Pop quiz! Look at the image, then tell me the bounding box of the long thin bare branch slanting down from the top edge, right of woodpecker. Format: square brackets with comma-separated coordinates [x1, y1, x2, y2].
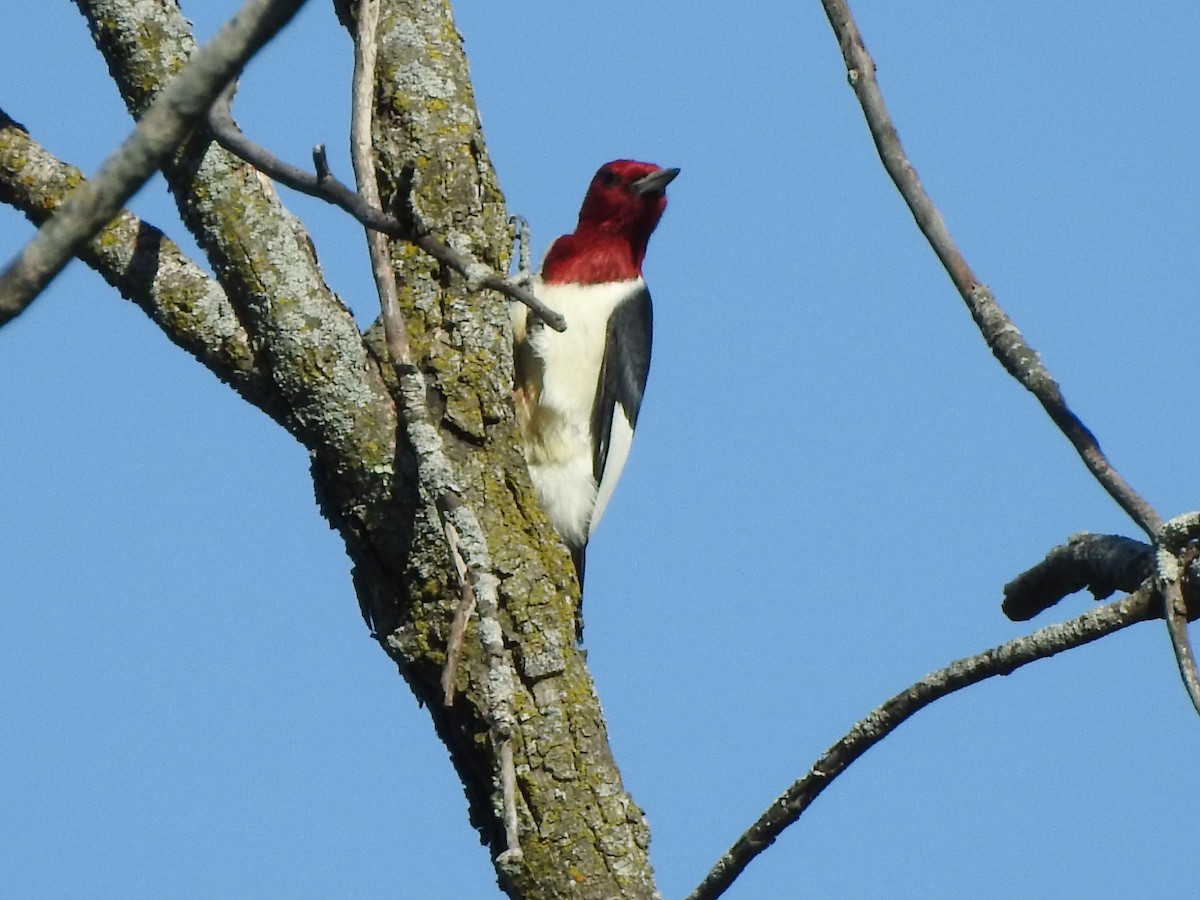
[821, 0, 1163, 539]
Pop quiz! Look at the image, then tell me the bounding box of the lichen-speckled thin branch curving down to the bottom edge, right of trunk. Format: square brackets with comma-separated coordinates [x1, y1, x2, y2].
[688, 582, 1160, 900]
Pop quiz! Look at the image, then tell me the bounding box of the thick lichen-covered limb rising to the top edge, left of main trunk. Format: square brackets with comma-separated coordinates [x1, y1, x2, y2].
[76, 0, 396, 509]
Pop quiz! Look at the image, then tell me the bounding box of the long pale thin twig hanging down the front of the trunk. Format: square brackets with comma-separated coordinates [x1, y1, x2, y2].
[345, 0, 522, 864]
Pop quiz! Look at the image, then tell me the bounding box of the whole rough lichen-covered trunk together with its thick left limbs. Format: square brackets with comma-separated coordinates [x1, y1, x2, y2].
[21, 0, 658, 900]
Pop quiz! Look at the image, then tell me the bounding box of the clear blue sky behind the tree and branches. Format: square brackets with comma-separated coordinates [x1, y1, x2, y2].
[0, 0, 1200, 900]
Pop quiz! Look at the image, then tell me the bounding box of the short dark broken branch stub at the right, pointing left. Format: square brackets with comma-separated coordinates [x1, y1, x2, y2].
[1001, 534, 1153, 622]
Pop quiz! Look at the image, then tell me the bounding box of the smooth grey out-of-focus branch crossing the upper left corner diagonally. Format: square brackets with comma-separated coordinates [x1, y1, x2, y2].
[0, 0, 305, 325]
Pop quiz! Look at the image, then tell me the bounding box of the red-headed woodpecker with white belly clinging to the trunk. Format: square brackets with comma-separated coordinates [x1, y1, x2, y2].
[512, 160, 679, 600]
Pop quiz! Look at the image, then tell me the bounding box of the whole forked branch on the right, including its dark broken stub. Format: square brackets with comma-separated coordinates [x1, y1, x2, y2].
[688, 0, 1200, 900]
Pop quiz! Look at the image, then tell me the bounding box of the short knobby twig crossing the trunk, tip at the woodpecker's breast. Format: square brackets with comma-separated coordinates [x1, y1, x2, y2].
[209, 91, 566, 331]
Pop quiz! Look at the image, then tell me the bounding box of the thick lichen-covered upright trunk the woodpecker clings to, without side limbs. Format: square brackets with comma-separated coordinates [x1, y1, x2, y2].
[355, 0, 658, 900]
